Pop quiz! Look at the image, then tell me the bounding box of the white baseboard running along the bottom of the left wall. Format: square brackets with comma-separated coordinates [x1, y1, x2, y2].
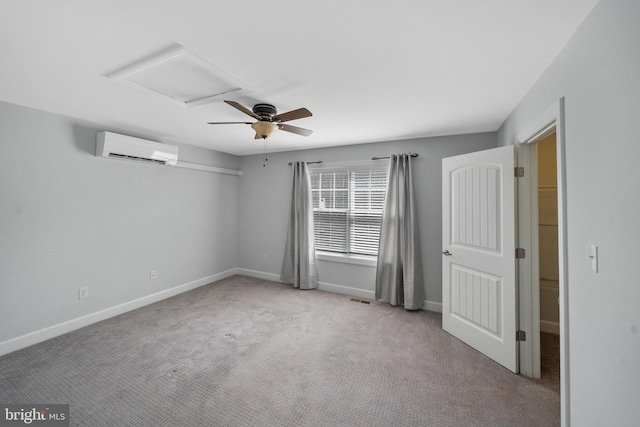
[0, 268, 238, 356]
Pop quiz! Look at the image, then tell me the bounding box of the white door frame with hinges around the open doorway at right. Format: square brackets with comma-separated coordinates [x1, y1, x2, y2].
[515, 97, 570, 426]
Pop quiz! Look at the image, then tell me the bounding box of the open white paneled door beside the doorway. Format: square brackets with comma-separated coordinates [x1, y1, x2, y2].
[442, 146, 518, 372]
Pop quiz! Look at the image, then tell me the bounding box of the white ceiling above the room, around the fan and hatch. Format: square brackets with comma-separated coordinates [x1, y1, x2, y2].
[0, 0, 597, 155]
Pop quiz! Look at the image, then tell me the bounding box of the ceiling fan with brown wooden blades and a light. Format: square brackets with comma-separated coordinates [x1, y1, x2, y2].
[208, 101, 313, 139]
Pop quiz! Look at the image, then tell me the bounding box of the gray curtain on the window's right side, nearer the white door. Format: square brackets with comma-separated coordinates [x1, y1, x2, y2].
[376, 154, 424, 310]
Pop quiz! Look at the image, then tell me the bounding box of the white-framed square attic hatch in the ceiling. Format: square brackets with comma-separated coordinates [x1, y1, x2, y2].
[106, 46, 250, 107]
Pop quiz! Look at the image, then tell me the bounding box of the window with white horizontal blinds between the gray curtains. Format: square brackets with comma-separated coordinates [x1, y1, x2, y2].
[311, 161, 389, 256]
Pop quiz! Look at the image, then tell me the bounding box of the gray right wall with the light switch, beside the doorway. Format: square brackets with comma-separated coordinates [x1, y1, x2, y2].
[498, 0, 640, 426]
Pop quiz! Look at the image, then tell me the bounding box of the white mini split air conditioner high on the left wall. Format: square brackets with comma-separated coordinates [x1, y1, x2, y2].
[96, 132, 178, 166]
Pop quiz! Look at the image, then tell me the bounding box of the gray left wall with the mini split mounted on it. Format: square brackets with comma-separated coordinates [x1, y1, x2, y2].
[0, 103, 239, 343]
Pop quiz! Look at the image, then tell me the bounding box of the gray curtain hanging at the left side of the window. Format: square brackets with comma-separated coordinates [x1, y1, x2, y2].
[280, 162, 318, 289]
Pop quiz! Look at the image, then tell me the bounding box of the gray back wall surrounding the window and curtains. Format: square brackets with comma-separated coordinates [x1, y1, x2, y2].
[238, 133, 496, 309]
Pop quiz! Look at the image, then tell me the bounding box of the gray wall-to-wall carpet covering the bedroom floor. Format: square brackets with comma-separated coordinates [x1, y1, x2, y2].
[0, 276, 560, 426]
